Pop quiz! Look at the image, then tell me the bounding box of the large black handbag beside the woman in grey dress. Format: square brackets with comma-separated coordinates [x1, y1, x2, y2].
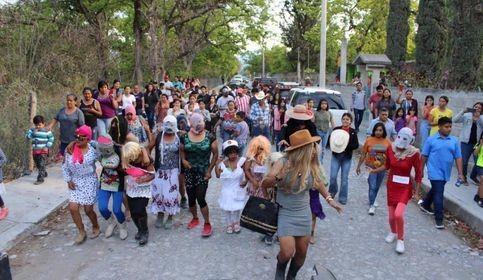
[240, 196, 281, 236]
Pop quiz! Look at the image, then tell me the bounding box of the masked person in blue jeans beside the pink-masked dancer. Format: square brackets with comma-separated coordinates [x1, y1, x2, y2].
[97, 136, 127, 240]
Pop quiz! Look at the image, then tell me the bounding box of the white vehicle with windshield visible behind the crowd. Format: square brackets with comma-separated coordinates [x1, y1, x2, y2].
[288, 87, 348, 126]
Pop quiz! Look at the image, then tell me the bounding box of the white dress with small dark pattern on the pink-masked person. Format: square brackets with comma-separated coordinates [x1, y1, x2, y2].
[62, 145, 99, 205]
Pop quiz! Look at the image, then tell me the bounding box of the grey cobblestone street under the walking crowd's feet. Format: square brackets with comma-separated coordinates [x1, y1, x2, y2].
[10, 152, 483, 280]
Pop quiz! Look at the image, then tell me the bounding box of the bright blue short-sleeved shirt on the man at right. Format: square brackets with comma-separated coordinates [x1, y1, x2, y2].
[421, 133, 461, 182]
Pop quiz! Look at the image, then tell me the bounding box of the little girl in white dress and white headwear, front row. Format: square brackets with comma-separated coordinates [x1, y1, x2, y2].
[215, 140, 248, 234]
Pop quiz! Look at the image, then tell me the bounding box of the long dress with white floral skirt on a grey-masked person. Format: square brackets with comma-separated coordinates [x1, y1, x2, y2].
[151, 137, 180, 215]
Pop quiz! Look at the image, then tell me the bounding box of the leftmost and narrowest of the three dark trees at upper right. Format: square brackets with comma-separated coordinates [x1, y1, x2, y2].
[386, 0, 411, 70]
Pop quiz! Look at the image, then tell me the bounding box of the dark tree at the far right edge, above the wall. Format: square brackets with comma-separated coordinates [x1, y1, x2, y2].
[449, 0, 483, 89]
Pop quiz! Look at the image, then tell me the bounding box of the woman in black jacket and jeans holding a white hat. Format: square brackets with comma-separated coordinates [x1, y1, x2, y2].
[329, 113, 359, 205]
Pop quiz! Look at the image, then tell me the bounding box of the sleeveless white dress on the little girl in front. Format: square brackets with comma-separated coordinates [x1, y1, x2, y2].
[218, 157, 248, 211]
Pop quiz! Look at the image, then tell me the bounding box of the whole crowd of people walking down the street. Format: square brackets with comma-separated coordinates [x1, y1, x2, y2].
[0, 76, 483, 279]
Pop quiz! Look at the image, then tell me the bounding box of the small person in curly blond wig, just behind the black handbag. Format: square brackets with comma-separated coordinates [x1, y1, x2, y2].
[243, 135, 273, 245]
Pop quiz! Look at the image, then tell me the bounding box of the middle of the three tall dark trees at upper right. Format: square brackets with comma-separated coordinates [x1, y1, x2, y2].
[415, 0, 448, 86]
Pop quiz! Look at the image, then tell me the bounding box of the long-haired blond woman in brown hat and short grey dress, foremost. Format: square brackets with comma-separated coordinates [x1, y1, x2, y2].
[261, 129, 342, 279]
